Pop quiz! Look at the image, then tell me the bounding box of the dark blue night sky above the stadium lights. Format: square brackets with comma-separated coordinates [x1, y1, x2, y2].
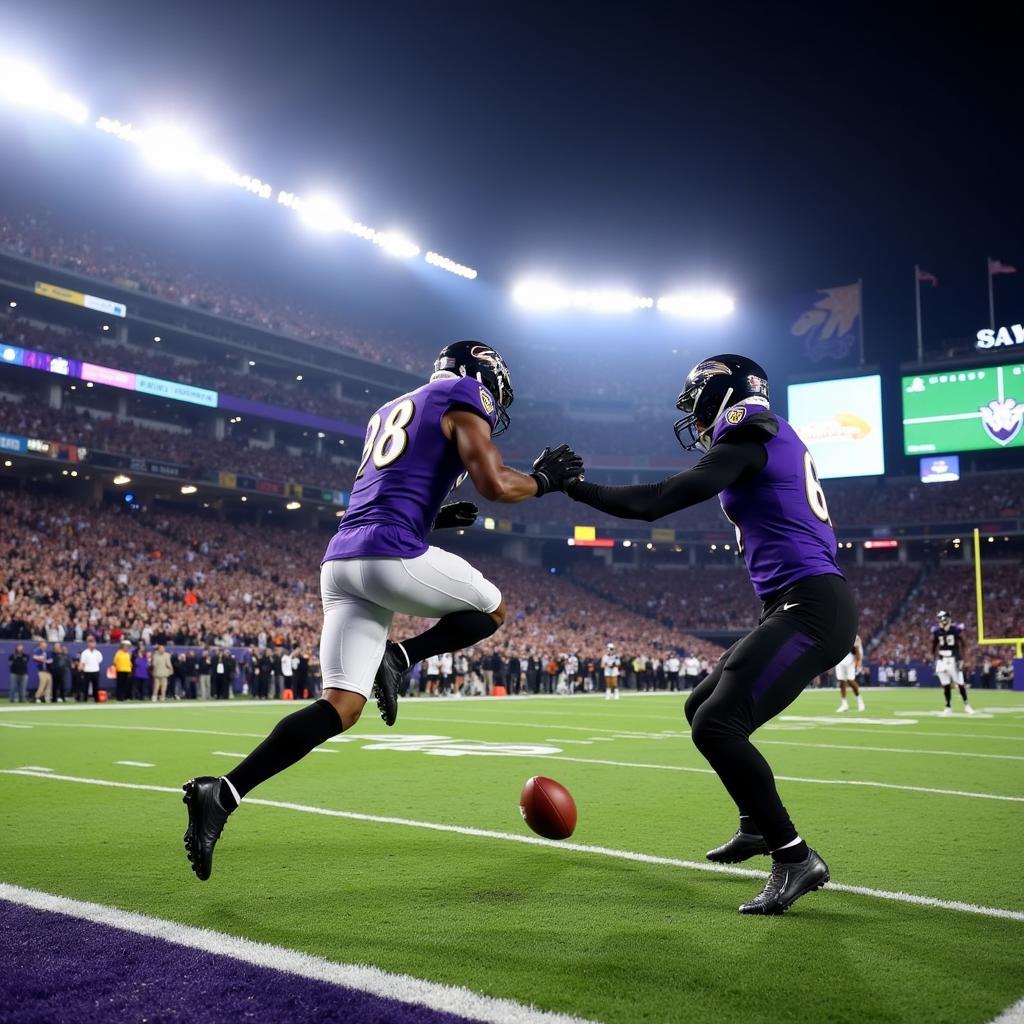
[3, 0, 1024, 362]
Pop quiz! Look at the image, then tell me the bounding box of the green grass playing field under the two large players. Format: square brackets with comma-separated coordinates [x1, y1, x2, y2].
[0, 690, 1024, 1024]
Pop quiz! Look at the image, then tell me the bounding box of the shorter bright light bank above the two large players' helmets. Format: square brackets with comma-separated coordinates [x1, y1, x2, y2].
[512, 278, 736, 321]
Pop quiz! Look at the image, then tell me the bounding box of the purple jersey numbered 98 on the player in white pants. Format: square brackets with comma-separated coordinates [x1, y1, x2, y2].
[324, 377, 496, 561]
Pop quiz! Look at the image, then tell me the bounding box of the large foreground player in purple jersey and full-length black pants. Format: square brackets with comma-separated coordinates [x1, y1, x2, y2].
[567, 355, 857, 913]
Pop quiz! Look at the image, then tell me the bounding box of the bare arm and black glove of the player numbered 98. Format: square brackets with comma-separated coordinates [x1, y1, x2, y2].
[442, 410, 583, 504]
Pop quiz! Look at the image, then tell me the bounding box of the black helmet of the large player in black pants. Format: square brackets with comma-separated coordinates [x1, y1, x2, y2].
[675, 355, 768, 452]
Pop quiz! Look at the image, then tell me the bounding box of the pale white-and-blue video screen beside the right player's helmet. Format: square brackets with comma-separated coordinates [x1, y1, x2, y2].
[786, 374, 886, 480]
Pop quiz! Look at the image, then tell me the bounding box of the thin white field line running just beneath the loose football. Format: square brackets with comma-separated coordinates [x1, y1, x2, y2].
[0, 759, 1024, 922]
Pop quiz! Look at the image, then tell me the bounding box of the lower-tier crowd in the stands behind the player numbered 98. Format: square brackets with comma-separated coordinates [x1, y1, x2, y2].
[0, 493, 720, 686]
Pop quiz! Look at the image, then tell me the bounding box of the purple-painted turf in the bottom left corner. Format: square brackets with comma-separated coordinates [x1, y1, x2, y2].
[0, 900, 465, 1024]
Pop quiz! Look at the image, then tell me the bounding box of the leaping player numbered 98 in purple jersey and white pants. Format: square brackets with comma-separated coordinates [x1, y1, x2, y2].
[183, 341, 583, 881]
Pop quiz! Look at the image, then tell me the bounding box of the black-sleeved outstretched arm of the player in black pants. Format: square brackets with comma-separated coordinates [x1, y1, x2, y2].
[566, 441, 768, 522]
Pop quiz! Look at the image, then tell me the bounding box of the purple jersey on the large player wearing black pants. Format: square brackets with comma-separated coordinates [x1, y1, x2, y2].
[712, 399, 843, 598]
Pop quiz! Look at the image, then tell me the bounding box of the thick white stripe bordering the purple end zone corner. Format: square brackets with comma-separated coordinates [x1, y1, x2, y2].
[0, 883, 587, 1024]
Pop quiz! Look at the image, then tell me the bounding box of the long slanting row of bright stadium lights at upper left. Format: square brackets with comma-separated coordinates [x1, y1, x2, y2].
[0, 56, 476, 281]
